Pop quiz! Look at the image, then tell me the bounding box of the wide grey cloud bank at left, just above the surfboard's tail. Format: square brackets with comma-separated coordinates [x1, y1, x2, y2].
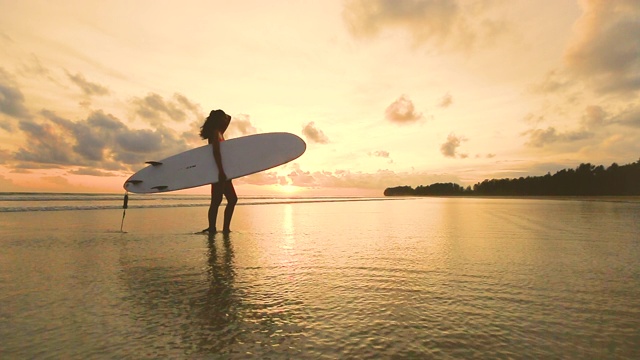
[10, 110, 189, 171]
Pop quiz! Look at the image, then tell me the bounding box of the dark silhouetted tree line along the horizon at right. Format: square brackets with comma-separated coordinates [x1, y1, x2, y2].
[384, 160, 640, 196]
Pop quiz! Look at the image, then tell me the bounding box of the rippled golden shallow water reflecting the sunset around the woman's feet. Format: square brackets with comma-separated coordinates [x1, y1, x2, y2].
[0, 198, 640, 358]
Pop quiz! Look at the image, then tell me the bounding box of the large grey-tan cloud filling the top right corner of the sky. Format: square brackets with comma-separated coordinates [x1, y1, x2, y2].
[564, 0, 640, 93]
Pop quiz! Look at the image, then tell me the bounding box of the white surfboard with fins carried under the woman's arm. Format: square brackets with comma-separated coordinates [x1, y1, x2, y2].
[123, 132, 307, 194]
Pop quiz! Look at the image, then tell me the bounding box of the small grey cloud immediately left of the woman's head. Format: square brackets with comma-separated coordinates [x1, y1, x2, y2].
[132, 93, 204, 126]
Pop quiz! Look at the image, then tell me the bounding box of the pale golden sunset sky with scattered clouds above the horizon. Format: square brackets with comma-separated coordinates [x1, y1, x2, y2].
[0, 0, 640, 196]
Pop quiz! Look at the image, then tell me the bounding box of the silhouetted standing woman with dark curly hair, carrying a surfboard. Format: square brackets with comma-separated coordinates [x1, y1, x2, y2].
[200, 110, 238, 234]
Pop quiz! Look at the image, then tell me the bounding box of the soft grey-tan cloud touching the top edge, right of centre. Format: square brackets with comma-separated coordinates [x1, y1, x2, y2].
[343, 0, 506, 50]
